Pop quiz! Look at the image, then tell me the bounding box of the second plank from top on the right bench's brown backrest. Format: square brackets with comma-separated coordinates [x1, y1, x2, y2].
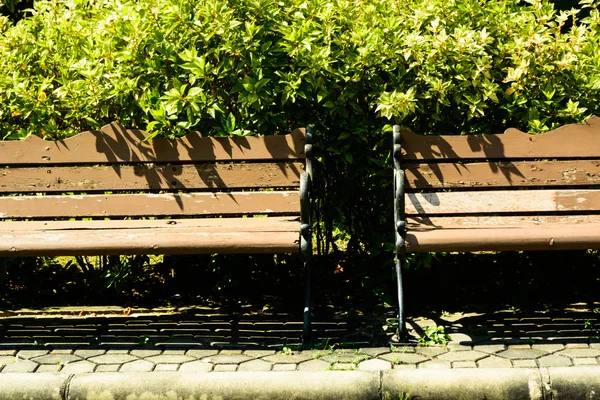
[406, 160, 600, 189]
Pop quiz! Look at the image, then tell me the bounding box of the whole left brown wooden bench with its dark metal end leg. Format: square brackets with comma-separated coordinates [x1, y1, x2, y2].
[0, 123, 312, 340]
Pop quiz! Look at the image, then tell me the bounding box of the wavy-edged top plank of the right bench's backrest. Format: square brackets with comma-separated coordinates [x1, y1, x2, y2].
[401, 116, 600, 160]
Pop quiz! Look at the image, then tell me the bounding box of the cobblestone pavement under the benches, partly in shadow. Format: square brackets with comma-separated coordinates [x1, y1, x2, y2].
[0, 306, 600, 374]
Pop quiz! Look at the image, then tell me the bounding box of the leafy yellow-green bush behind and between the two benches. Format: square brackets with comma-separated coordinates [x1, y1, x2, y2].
[0, 0, 600, 304]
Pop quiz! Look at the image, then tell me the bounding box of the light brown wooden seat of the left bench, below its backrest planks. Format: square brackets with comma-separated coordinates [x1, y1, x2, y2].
[0, 217, 300, 257]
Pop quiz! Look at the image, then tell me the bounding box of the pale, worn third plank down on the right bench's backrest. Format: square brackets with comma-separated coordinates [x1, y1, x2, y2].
[405, 190, 600, 215]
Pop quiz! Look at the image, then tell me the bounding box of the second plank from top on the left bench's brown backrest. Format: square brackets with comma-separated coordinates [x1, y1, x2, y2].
[0, 163, 304, 193]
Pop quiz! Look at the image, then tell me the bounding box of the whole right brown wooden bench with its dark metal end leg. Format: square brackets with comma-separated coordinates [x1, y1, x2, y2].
[393, 117, 600, 339]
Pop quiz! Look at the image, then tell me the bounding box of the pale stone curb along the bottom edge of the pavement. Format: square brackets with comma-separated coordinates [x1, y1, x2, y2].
[0, 367, 600, 400]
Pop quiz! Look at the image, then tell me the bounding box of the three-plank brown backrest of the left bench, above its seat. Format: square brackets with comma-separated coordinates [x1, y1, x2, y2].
[0, 123, 306, 220]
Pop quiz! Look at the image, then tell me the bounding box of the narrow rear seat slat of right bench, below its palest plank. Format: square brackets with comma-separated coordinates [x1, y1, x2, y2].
[406, 214, 600, 230]
